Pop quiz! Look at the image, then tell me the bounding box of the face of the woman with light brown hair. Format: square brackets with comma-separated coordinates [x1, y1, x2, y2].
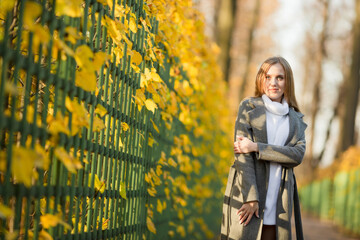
[263, 63, 285, 102]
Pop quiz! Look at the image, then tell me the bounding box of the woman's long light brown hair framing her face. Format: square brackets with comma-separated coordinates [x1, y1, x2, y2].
[255, 57, 300, 112]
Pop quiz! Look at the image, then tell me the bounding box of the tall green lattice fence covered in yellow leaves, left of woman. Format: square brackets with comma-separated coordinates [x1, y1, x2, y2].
[0, 0, 231, 239]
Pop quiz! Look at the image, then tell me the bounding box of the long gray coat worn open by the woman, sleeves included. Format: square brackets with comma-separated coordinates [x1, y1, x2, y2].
[221, 98, 307, 240]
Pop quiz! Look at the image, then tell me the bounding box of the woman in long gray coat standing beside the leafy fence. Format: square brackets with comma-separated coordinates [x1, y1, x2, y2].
[221, 57, 307, 240]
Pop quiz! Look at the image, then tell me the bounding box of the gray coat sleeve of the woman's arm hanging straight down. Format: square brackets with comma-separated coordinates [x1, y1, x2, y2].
[234, 100, 259, 202]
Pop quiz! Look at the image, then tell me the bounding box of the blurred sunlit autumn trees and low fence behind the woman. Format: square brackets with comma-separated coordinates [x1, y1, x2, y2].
[194, 0, 360, 239]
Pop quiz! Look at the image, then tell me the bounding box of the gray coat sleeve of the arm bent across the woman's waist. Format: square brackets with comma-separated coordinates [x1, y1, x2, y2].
[258, 128, 306, 168]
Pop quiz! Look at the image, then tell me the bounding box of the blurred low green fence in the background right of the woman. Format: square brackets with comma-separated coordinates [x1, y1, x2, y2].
[300, 169, 360, 235]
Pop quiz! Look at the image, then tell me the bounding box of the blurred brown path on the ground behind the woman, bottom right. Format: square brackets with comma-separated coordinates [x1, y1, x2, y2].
[292, 214, 360, 240]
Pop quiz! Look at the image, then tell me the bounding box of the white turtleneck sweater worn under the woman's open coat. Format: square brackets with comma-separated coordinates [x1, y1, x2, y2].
[262, 94, 289, 225]
